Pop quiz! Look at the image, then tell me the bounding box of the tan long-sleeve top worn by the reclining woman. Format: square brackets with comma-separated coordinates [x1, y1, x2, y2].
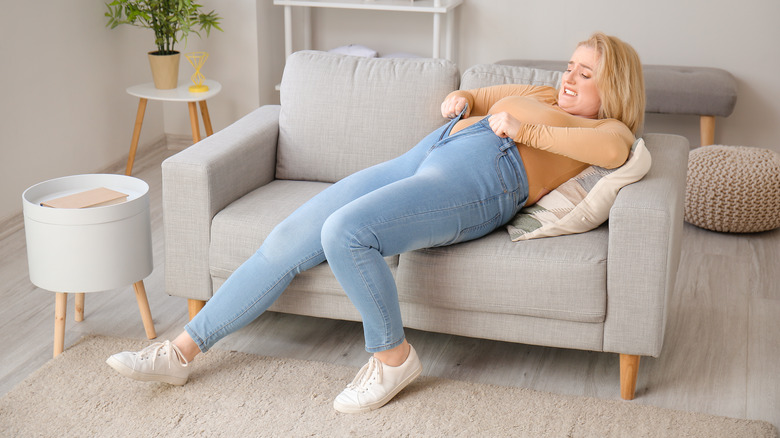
[448, 85, 635, 206]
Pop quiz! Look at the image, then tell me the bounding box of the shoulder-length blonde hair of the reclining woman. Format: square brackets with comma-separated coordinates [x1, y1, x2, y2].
[577, 32, 646, 135]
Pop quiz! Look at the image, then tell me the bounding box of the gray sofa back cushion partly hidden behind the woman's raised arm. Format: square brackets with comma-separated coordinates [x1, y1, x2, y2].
[460, 64, 563, 90]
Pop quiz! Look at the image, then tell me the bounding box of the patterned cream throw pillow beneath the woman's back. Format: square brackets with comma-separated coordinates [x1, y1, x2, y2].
[507, 138, 652, 241]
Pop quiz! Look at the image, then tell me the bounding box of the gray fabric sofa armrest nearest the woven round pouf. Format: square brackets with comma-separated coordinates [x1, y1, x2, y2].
[603, 134, 689, 357]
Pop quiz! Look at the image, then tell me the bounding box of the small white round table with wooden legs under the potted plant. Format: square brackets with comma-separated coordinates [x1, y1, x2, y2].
[125, 79, 222, 175]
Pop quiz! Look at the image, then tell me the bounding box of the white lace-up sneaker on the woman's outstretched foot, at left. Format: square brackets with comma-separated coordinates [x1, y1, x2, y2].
[106, 341, 190, 385]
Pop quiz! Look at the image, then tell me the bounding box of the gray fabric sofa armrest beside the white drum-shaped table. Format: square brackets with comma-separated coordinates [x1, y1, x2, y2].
[162, 105, 280, 301]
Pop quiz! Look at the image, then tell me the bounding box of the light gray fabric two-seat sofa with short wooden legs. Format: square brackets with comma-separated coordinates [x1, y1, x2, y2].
[162, 51, 688, 399]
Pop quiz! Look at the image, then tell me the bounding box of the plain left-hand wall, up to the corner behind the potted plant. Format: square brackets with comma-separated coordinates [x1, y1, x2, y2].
[0, 0, 163, 219]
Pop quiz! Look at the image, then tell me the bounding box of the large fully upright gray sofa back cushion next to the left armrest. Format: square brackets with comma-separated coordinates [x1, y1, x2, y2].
[276, 51, 459, 182]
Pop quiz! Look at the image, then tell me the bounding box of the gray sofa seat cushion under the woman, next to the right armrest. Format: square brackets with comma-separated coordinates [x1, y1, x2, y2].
[396, 225, 609, 323]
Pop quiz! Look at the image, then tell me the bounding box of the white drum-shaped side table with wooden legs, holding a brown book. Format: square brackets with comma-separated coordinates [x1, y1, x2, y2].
[22, 174, 157, 356]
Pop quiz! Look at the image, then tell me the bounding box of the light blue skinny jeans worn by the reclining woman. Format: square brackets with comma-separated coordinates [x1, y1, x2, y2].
[185, 112, 528, 353]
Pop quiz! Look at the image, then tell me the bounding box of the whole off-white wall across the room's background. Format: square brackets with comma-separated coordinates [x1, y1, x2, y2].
[0, 0, 780, 222]
